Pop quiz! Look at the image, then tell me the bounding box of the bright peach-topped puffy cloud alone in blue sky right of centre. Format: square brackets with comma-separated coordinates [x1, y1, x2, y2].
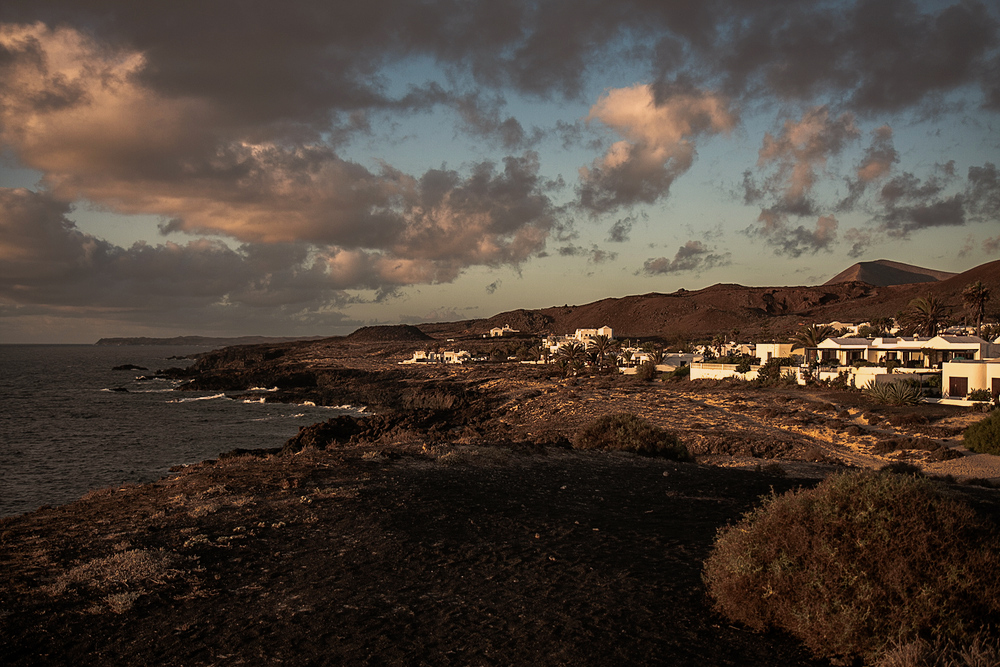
[578, 84, 737, 213]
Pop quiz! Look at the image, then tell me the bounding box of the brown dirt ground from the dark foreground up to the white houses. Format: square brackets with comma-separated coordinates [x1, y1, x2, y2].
[0, 344, 1000, 666]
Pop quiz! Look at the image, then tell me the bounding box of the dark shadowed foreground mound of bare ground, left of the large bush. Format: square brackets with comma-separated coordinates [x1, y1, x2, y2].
[0, 447, 824, 666]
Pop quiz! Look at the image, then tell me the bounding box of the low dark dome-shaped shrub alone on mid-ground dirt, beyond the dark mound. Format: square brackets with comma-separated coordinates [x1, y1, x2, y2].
[573, 412, 691, 461]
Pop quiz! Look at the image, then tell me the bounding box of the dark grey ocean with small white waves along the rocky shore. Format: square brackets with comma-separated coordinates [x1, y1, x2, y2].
[0, 345, 357, 516]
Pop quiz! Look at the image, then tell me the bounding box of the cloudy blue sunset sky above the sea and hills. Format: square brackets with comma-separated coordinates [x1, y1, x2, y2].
[0, 0, 1000, 343]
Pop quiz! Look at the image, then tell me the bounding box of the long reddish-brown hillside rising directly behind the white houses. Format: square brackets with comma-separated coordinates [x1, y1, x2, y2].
[420, 260, 1000, 339]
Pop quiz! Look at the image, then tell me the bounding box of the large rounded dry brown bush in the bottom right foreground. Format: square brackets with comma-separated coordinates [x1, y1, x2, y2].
[704, 473, 1000, 659]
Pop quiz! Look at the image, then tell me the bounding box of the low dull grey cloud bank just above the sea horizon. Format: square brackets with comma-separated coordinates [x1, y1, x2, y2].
[0, 188, 360, 318]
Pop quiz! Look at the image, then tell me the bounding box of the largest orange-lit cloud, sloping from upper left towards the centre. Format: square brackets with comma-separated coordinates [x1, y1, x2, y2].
[0, 24, 555, 286]
